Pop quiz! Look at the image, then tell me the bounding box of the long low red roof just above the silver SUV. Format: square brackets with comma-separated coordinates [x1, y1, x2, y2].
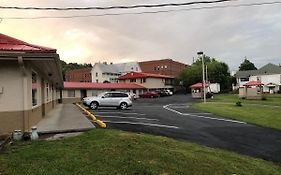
[64, 82, 146, 89]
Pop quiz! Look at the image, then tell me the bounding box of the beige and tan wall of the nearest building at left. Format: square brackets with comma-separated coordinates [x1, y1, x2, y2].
[0, 61, 57, 135]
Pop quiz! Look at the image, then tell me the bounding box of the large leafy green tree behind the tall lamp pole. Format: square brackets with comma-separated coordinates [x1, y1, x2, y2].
[177, 56, 232, 90]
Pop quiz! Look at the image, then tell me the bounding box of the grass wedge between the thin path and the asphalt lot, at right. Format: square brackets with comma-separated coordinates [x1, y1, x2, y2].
[192, 102, 281, 130]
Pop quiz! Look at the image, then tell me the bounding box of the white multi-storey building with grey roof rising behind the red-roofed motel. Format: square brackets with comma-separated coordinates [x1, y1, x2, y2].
[91, 62, 141, 83]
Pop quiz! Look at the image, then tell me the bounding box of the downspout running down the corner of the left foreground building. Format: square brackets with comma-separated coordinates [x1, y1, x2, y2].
[18, 56, 29, 132]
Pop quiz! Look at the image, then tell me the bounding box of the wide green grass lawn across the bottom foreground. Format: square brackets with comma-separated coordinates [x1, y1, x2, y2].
[0, 129, 281, 175]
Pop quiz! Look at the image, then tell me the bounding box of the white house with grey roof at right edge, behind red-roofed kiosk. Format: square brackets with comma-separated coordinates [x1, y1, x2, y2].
[236, 63, 281, 93]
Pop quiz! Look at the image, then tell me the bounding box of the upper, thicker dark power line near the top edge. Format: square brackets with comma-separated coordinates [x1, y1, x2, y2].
[0, 0, 235, 11]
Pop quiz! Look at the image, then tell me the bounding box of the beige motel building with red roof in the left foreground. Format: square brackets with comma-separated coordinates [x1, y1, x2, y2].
[0, 33, 63, 135]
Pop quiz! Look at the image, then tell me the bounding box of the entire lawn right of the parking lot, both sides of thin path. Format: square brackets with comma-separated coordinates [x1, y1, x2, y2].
[192, 94, 281, 130]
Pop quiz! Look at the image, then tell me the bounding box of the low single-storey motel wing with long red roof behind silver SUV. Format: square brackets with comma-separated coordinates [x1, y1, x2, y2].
[62, 82, 146, 103]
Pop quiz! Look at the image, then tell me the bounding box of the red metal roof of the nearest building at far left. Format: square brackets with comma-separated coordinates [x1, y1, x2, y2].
[0, 33, 56, 53]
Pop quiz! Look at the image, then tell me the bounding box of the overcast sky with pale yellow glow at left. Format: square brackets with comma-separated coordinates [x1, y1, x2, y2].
[0, 0, 281, 70]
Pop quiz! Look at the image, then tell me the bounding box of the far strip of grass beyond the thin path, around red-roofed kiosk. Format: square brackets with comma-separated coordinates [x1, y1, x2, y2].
[208, 94, 281, 106]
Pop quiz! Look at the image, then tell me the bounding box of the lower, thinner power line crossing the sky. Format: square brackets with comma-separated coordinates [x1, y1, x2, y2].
[1, 1, 281, 20]
